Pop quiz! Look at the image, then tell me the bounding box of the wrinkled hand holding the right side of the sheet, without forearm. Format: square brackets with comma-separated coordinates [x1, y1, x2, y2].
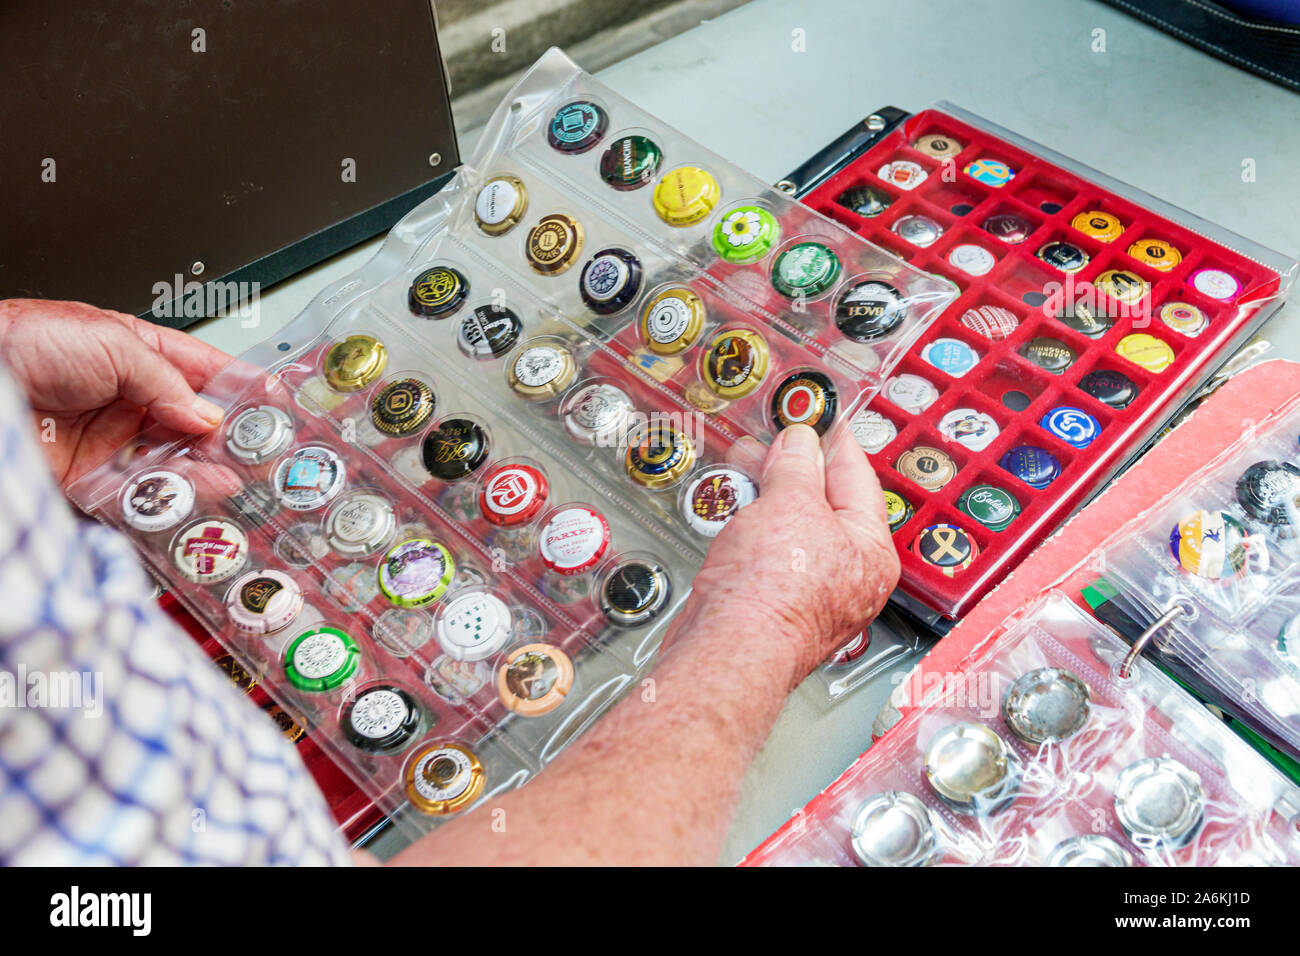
[694, 425, 898, 680]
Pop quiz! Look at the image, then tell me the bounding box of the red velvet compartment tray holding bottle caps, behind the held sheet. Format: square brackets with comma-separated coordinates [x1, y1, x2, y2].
[803, 111, 1281, 618]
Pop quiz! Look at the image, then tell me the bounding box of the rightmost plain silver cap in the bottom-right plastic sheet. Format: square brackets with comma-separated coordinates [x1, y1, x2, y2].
[1115, 757, 1205, 848]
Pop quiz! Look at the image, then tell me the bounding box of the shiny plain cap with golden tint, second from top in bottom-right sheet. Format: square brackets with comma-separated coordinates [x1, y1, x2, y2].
[926, 721, 1019, 816]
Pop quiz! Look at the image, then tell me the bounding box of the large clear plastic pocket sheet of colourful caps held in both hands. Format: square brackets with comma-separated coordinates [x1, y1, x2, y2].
[65, 51, 956, 832]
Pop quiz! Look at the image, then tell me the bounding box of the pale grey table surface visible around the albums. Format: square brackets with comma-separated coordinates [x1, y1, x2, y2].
[195, 0, 1300, 861]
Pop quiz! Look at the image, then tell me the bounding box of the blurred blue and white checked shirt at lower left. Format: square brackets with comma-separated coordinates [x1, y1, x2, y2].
[0, 365, 350, 865]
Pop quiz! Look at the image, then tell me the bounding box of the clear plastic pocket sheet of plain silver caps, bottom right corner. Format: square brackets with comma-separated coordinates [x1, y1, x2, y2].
[745, 592, 1300, 866]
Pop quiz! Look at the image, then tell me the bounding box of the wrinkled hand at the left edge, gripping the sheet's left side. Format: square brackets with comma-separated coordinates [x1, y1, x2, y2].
[0, 299, 230, 486]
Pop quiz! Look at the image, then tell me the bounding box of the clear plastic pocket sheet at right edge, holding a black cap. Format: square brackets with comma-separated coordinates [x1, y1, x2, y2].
[1096, 390, 1300, 758]
